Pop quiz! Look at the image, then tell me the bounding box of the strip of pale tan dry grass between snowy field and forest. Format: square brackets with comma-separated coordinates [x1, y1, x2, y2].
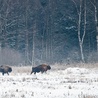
[4, 63, 98, 75]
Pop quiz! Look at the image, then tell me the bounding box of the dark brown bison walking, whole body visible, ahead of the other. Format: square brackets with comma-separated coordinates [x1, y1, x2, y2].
[31, 64, 51, 74]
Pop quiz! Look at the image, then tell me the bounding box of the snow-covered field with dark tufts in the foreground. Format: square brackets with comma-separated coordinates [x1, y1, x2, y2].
[0, 67, 98, 98]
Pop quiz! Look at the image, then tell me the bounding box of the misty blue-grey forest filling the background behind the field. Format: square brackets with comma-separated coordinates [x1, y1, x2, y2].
[0, 0, 98, 65]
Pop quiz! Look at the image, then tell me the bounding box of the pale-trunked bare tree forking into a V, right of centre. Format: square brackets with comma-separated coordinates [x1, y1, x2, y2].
[72, 0, 86, 62]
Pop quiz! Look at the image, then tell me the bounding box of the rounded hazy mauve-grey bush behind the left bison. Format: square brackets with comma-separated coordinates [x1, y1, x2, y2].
[0, 48, 24, 65]
